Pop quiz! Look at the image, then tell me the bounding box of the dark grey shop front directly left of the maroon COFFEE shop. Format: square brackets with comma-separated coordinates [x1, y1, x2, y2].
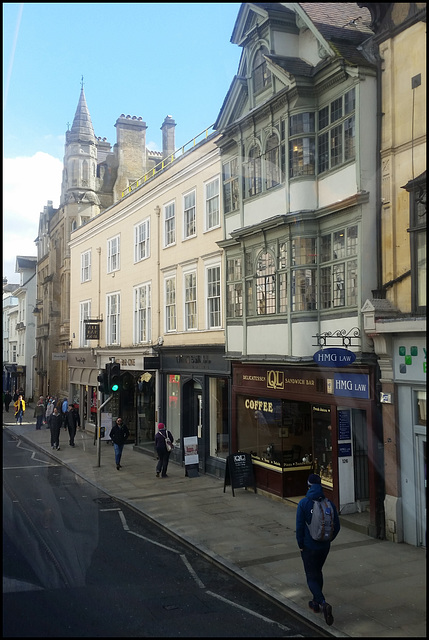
[161, 346, 231, 478]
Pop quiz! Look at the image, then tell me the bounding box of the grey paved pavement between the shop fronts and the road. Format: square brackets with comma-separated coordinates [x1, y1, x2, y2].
[3, 407, 427, 638]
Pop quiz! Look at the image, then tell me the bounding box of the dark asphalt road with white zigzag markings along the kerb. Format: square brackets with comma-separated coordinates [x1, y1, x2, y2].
[3, 432, 321, 637]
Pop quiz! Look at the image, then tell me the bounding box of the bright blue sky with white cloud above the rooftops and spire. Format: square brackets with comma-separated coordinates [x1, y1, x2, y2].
[2, 2, 242, 283]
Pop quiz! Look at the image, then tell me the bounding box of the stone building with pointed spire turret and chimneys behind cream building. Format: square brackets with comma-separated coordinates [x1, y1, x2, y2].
[35, 86, 175, 396]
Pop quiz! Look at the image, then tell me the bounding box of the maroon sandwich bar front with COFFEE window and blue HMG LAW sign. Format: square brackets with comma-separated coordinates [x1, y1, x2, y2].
[232, 363, 382, 532]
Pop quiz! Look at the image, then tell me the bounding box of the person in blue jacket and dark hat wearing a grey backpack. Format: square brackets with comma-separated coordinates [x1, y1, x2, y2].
[296, 473, 340, 625]
